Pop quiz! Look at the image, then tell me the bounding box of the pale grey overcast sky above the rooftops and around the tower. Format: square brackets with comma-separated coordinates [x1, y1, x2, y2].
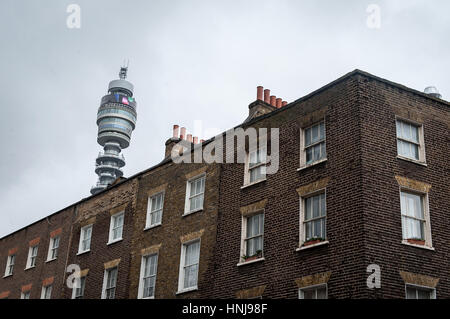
[0, 0, 450, 237]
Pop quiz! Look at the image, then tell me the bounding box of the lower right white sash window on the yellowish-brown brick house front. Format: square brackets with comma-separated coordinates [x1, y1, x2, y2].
[178, 240, 200, 292]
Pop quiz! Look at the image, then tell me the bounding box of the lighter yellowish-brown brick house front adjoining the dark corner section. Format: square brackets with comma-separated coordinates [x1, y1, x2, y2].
[129, 163, 220, 298]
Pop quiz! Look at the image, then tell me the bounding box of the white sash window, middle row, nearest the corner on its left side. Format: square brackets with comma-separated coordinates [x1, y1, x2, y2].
[300, 193, 327, 244]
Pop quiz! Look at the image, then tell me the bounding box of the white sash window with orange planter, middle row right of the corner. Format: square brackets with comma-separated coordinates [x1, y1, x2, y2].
[400, 191, 431, 246]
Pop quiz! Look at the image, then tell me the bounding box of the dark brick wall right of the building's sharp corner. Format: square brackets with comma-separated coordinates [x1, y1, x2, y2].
[359, 77, 450, 298]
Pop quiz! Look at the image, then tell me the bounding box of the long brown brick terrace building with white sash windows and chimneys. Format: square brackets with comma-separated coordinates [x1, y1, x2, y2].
[0, 70, 450, 298]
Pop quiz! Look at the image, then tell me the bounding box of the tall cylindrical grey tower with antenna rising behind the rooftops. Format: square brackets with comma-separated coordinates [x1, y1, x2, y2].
[91, 67, 137, 194]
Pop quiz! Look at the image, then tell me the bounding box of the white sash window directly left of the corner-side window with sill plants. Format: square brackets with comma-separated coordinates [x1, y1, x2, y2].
[241, 213, 264, 262]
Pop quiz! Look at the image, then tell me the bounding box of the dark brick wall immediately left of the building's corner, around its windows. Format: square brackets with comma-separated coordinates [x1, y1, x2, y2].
[212, 75, 365, 298]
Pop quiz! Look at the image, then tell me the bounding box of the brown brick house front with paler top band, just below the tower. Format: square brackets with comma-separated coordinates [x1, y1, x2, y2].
[61, 179, 138, 299]
